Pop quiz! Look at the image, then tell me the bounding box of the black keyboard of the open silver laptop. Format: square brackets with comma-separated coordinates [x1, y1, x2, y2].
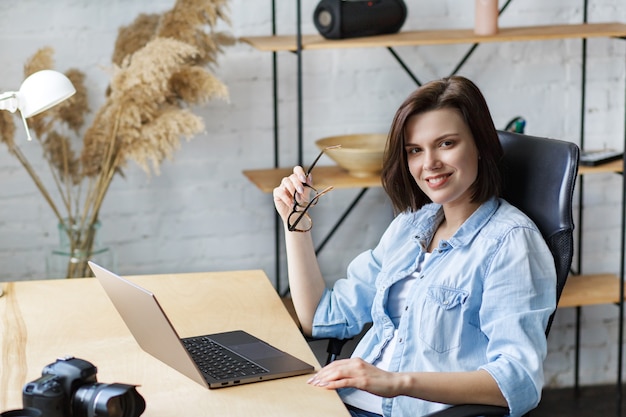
[182, 336, 268, 380]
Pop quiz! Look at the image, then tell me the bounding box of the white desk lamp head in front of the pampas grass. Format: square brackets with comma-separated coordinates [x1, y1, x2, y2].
[0, 70, 76, 140]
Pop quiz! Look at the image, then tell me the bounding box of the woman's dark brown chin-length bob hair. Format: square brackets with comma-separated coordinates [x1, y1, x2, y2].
[381, 76, 503, 213]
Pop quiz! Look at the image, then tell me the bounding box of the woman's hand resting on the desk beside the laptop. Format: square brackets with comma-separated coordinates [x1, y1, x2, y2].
[307, 358, 400, 397]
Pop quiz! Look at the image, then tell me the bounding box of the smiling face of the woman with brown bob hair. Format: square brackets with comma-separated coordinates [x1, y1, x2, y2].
[405, 108, 478, 207]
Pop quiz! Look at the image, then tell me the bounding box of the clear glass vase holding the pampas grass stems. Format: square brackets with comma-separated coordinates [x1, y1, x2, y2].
[46, 221, 116, 278]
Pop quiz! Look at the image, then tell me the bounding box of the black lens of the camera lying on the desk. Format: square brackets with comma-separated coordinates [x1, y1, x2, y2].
[72, 383, 146, 417]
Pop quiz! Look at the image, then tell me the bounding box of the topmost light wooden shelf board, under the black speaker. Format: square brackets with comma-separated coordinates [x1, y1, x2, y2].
[239, 22, 626, 52]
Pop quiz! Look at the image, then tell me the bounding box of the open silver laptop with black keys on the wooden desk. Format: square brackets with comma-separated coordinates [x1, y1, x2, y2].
[89, 262, 313, 388]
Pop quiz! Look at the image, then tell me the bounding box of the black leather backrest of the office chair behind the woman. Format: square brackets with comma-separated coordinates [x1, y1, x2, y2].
[498, 132, 579, 334]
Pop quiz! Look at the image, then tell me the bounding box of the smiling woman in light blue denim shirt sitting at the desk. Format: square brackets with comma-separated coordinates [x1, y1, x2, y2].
[274, 76, 556, 417]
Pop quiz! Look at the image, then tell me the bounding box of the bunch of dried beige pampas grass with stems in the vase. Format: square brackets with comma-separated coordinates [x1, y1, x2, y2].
[0, 0, 235, 277]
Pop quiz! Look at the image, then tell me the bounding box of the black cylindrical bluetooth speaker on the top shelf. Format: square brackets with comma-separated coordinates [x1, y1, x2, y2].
[313, 0, 406, 39]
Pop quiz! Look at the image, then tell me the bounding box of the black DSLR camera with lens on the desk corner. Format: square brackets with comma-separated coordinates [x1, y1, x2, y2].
[22, 357, 146, 417]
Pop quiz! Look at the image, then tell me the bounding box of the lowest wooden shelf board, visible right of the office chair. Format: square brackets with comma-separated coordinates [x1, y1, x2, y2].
[559, 274, 619, 308]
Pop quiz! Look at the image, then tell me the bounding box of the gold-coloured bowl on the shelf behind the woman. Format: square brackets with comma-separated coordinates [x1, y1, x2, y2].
[315, 133, 387, 178]
